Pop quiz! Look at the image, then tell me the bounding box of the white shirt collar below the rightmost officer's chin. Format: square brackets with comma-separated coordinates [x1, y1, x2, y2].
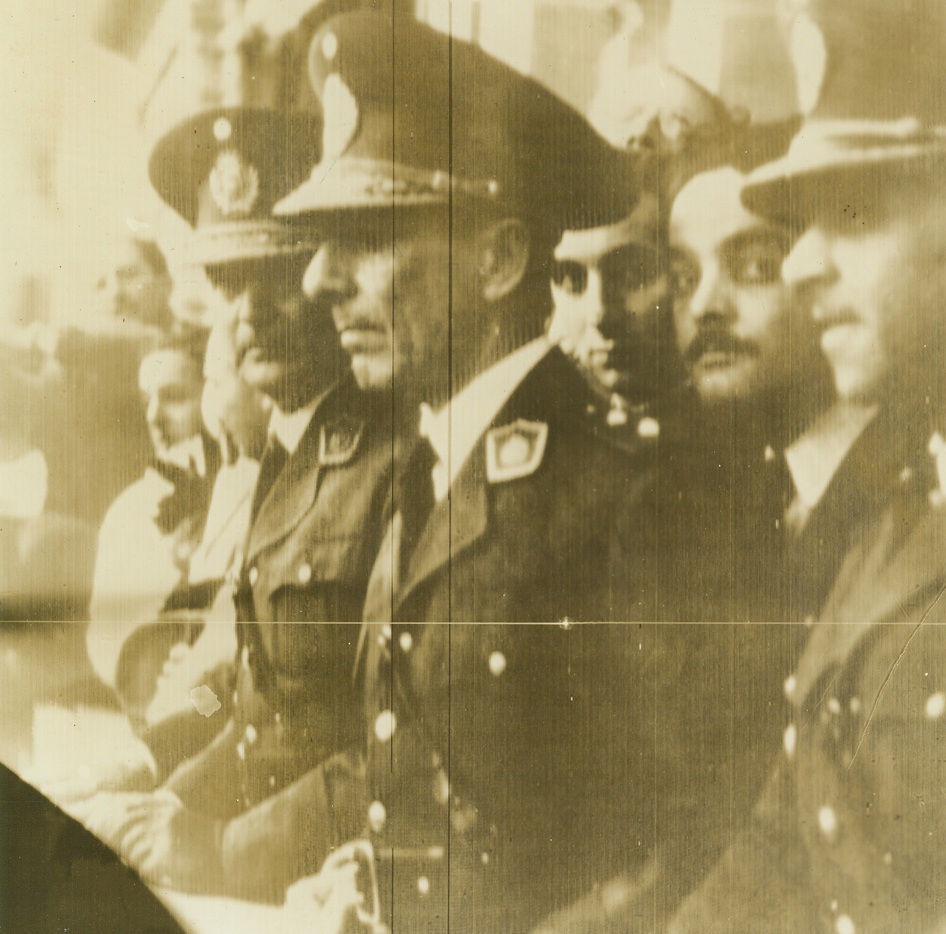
[785, 400, 879, 510]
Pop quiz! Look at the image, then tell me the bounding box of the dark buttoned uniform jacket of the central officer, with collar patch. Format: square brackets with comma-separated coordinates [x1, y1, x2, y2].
[354, 351, 716, 932]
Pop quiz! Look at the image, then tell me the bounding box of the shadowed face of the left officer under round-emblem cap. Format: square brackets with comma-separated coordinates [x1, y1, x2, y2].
[206, 253, 337, 412]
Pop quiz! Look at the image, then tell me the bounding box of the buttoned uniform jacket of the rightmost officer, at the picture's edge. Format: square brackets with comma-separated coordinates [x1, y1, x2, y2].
[671, 464, 946, 934]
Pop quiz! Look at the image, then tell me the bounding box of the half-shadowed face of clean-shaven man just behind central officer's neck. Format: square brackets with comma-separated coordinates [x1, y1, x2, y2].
[549, 193, 668, 395]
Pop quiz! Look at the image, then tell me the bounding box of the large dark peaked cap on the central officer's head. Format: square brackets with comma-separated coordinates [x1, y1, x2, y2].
[275, 12, 638, 229]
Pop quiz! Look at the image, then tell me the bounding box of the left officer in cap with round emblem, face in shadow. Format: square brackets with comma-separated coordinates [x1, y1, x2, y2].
[74, 108, 393, 901]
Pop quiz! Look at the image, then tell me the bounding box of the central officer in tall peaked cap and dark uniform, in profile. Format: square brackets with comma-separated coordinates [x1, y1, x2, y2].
[275, 14, 728, 931]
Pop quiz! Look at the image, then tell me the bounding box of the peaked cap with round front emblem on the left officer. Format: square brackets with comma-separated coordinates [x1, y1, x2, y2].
[148, 107, 322, 265]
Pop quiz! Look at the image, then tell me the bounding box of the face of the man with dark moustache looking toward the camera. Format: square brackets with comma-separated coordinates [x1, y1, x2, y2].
[670, 168, 816, 403]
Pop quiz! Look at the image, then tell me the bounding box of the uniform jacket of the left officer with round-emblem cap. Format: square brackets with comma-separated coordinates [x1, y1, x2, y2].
[170, 381, 402, 899]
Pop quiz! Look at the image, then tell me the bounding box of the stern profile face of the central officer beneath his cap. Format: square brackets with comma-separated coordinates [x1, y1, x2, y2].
[304, 207, 464, 399]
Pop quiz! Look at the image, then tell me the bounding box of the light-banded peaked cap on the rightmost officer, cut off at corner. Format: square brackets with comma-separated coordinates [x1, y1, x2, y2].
[743, 0, 946, 217]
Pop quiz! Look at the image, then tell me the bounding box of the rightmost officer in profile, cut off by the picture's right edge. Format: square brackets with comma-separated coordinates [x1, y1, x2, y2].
[671, 0, 946, 934]
